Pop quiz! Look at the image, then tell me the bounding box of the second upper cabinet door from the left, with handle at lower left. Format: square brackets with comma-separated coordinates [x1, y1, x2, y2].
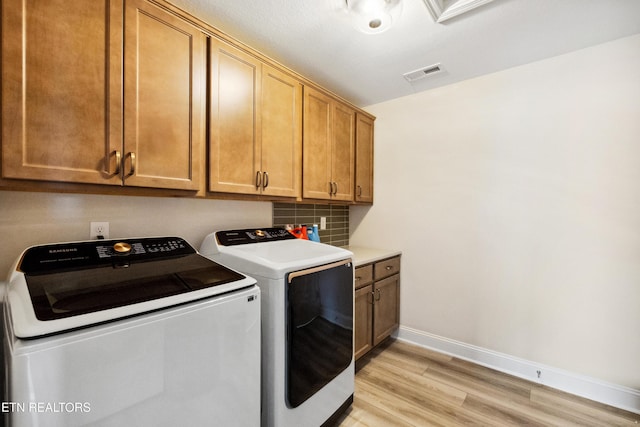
[123, 0, 206, 190]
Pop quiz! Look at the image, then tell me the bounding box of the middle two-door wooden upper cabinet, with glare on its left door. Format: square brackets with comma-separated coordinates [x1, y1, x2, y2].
[209, 39, 302, 197]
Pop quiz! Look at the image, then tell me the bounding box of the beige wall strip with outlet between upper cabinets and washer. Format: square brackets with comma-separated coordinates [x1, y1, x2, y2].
[0, 191, 272, 281]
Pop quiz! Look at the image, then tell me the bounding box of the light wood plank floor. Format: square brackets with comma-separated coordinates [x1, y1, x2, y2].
[337, 340, 640, 427]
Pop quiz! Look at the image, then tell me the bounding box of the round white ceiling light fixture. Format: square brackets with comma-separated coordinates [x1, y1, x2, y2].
[345, 0, 402, 34]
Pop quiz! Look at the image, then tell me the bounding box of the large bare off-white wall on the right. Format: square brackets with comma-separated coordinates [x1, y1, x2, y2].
[351, 35, 640, 390]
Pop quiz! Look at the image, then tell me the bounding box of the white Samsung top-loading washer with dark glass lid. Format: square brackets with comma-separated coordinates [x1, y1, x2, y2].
[3, 237, 260, 427]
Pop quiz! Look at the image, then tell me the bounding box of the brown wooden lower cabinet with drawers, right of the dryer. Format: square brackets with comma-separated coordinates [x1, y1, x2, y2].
[353, 256, 400, 360]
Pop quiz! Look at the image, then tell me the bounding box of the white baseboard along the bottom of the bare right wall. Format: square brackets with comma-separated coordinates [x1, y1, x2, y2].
[395, 326, 640, 414]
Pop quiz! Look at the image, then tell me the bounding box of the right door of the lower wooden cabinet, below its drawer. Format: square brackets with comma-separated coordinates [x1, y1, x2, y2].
[373, 274, 400, 346]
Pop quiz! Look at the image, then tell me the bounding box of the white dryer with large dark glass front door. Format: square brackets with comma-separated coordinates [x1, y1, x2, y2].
[200, 228, 354, 427]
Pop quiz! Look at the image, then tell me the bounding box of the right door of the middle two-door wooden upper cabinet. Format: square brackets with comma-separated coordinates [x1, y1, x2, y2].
[260, 65, 302, 197]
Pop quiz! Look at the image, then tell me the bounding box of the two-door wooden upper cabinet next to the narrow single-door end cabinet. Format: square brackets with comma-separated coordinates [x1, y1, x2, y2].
[302, 87, 355, 201]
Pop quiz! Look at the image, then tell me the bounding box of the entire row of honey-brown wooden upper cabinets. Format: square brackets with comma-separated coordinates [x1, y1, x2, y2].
[0, 0, 364, 203]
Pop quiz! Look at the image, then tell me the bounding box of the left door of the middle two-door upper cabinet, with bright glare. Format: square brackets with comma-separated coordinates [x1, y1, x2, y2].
[209, 39, 262, 194]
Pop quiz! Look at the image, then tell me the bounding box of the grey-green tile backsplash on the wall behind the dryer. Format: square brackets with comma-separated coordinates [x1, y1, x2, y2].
[273, 203, 349, 246]
